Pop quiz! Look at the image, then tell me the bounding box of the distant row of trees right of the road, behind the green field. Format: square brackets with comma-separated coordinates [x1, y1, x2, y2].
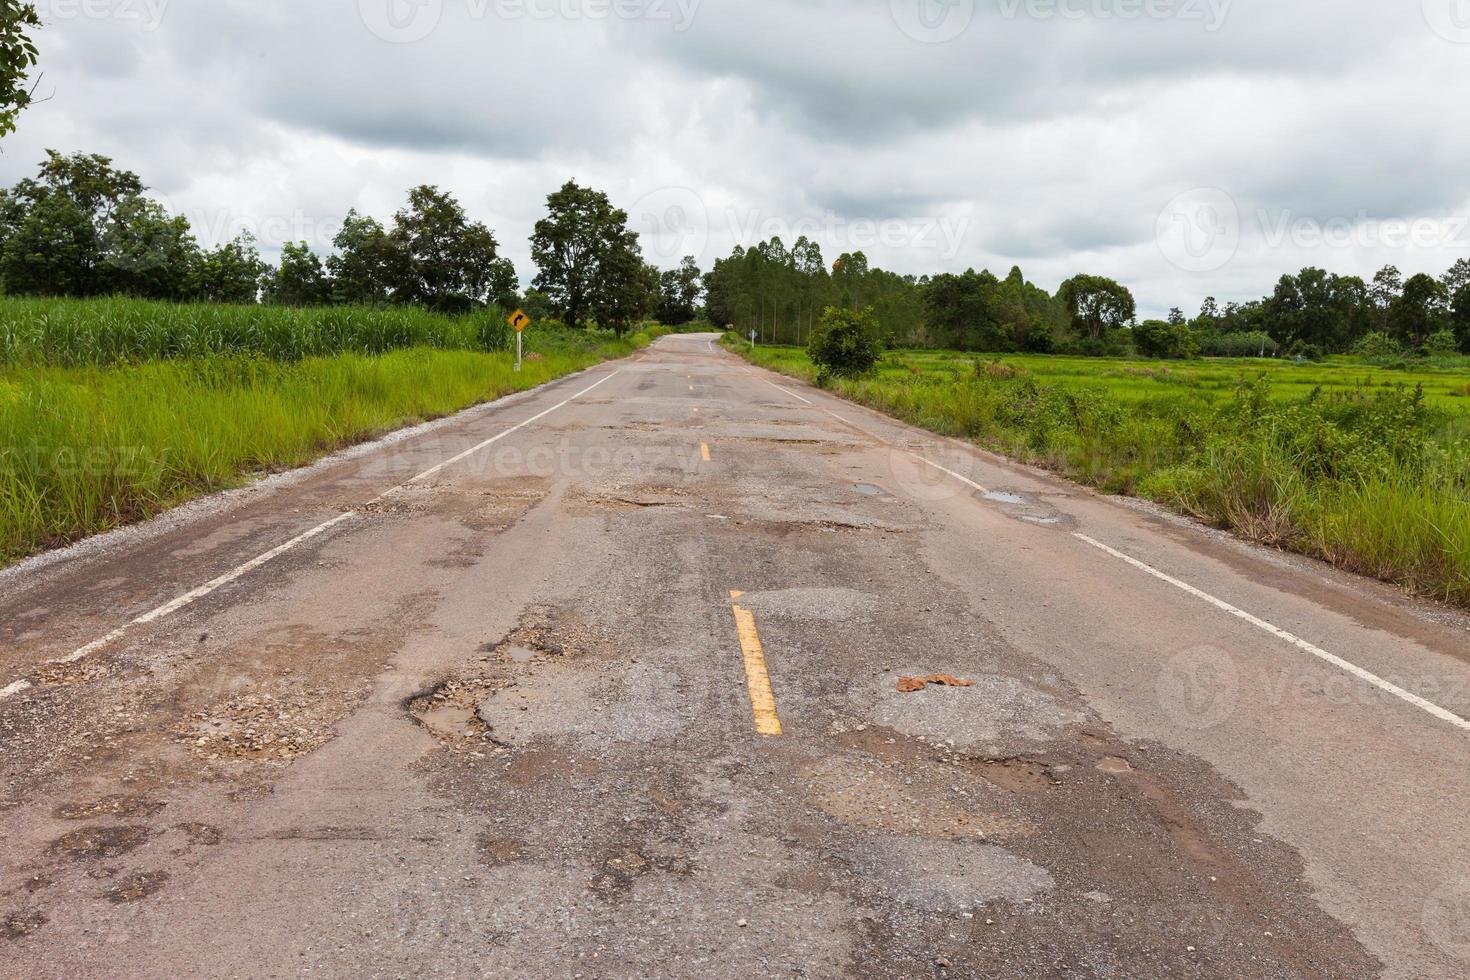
[704, 237, 1470, 357]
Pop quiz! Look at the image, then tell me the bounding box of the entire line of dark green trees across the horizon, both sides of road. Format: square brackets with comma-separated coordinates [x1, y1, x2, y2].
[0, 151, 1470, 357]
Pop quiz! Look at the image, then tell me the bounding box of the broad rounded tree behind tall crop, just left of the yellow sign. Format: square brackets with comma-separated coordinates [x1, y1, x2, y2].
[388, 184, 515, 310]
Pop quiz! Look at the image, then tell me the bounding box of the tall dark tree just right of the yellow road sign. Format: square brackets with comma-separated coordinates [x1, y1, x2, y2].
[531, 181, 642, 333]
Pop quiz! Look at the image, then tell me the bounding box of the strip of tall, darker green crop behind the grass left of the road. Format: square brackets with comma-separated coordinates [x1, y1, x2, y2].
[0, 297, 513, 366]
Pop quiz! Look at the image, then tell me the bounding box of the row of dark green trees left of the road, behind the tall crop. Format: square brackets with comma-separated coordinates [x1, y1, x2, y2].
[0, 151, 700, 334]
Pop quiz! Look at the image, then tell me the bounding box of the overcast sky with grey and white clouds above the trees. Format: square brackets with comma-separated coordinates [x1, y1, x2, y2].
[0, 0, 1470, 314]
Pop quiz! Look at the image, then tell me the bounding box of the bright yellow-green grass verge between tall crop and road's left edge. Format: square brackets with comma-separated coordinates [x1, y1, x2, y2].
[0, 331, 657, 564]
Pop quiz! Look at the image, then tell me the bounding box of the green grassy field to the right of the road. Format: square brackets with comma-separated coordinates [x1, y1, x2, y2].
[726, 338, 1470, 607]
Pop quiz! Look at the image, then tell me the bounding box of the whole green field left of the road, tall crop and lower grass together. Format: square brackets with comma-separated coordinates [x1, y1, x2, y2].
[0, 300, 661, 564]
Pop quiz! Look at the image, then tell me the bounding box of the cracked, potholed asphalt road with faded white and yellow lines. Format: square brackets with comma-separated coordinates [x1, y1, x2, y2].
[0, 335, 1470, 979]
